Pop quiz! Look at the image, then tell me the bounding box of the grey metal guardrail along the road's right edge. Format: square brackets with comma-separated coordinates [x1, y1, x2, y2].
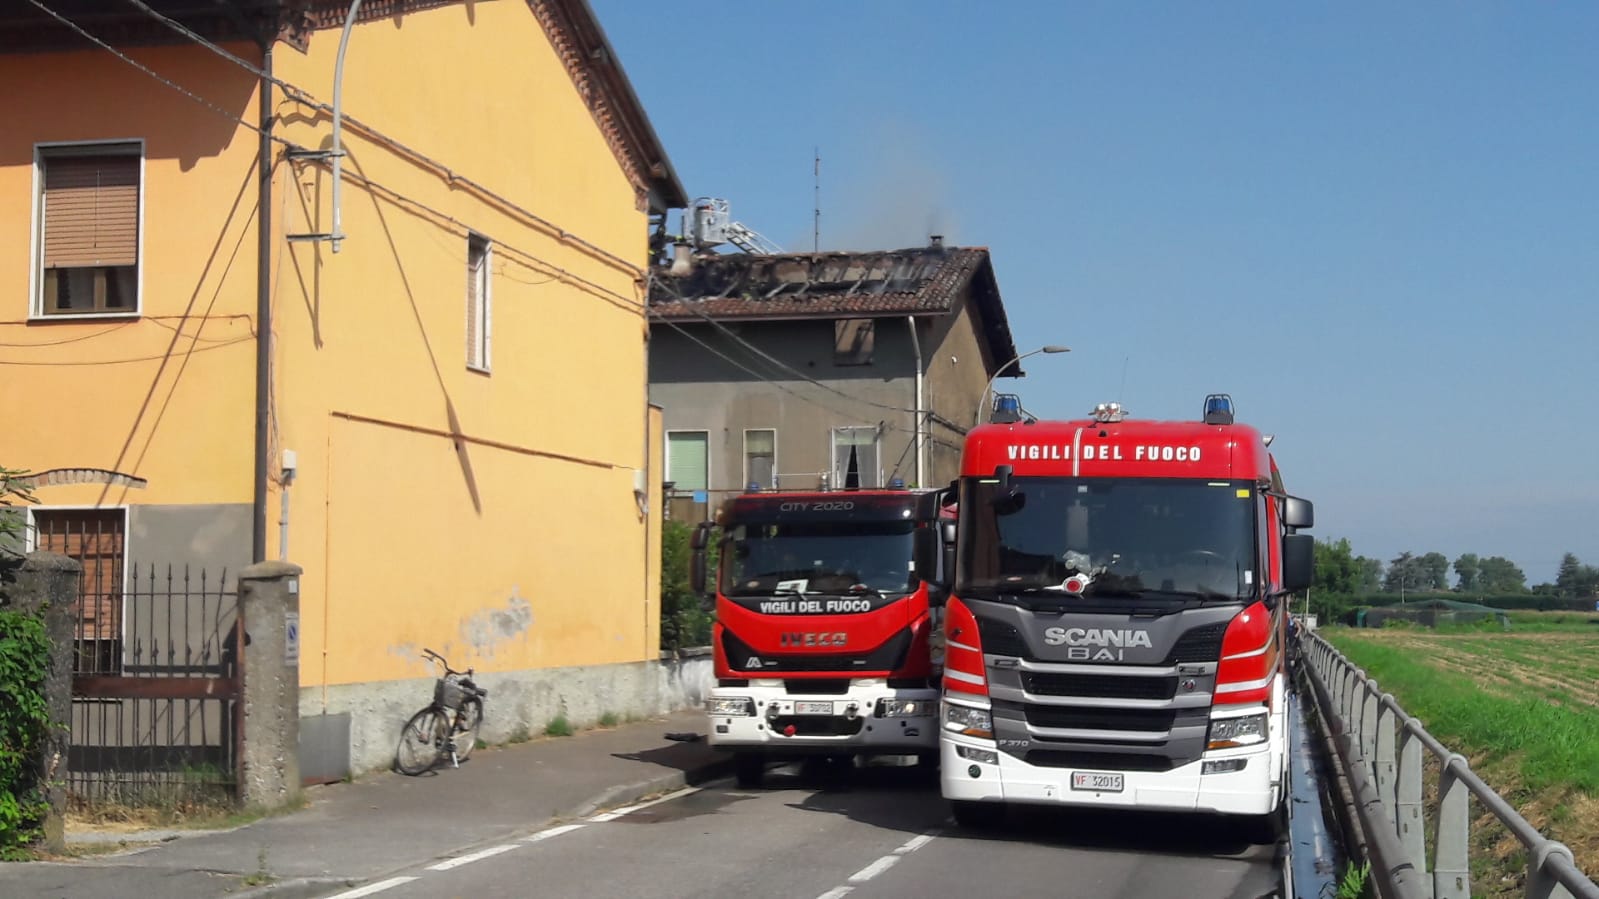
[1300, 633, 1599, 899]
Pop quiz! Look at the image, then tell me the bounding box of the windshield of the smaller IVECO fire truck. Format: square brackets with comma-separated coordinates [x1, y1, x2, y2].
[721, 521, 916, 597]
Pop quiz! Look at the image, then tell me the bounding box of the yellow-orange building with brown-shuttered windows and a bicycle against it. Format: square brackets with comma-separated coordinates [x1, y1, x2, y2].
[0, 0, 686, 769]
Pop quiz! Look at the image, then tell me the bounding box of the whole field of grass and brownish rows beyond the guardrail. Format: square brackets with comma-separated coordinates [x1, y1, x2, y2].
[1321, 613, 1599, 896]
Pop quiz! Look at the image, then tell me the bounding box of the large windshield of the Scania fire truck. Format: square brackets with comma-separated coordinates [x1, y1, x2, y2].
[955, 478, 1260, 600]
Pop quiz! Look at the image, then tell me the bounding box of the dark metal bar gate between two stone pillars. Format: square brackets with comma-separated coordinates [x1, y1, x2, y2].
[35, 510, 243, 809]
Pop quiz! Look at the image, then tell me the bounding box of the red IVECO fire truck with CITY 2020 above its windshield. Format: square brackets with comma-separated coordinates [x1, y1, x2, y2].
[692, 489, 955, 787]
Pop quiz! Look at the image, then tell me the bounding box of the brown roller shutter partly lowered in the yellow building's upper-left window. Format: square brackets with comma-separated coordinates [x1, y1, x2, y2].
[45, 155, 139, 269]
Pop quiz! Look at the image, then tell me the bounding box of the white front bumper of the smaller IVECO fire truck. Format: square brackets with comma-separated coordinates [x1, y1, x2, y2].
[705, 680, 939, 757]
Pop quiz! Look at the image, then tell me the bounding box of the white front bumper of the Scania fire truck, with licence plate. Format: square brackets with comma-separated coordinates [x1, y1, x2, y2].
[939, 733, 1284, 814]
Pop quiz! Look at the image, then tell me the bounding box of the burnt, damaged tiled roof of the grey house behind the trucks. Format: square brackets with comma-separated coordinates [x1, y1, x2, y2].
[649, 245, 1015, 374]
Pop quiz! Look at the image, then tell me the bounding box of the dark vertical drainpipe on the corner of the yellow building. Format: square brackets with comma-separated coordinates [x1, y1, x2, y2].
[251, 43, 277, 561]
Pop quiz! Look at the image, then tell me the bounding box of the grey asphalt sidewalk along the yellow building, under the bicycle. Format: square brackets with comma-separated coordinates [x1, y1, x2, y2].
[0, 710, 731, 899]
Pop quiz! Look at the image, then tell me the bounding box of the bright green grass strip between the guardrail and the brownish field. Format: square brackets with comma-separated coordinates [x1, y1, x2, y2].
[1329, 630, 1599, 793]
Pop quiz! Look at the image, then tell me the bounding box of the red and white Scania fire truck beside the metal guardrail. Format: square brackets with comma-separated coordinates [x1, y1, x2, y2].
[939, 394, 1313, 841]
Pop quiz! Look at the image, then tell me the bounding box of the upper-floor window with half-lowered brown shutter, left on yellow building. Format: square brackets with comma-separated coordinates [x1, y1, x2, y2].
[37, 144, 142, 315]
